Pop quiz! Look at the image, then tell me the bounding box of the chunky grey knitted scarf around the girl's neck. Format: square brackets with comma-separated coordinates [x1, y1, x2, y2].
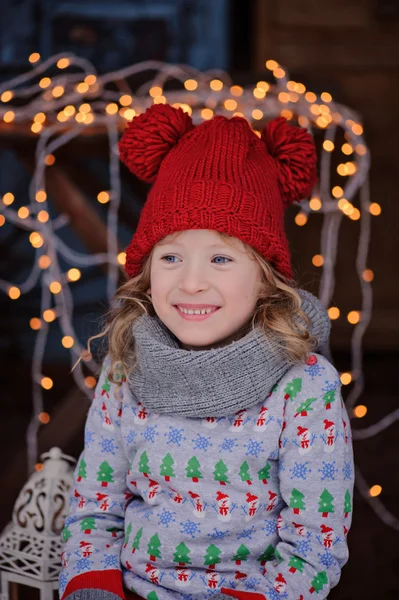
[128, 290, 330, 417]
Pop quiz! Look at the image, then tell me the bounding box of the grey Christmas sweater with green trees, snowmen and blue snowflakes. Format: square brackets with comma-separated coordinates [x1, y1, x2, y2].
[59, 354, 354, 600]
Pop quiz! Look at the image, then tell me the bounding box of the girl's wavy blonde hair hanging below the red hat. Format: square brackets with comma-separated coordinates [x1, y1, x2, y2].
[88, 232, 317, 385]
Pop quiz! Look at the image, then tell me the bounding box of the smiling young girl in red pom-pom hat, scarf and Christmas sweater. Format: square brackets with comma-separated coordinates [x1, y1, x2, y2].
[60, 105, 353, 600]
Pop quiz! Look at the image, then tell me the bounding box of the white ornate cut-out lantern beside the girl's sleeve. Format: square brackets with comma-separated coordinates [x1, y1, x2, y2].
[0, 448, 76, 600]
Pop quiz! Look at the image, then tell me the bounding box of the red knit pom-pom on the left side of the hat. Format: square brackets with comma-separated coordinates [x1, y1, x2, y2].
[119, 104, 194, 183]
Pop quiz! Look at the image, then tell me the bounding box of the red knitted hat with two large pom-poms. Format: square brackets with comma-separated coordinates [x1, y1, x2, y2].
[119, 104, 317, 278]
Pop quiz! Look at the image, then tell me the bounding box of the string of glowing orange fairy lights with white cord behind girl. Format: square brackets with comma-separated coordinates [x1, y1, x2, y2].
[0, 53, 399, 530]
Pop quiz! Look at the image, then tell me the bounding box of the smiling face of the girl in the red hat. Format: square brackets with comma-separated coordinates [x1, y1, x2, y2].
[150, 229, 262, 350]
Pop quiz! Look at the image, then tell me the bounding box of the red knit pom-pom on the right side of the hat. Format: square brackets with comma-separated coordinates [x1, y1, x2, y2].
[261, 117, 317, 205]
